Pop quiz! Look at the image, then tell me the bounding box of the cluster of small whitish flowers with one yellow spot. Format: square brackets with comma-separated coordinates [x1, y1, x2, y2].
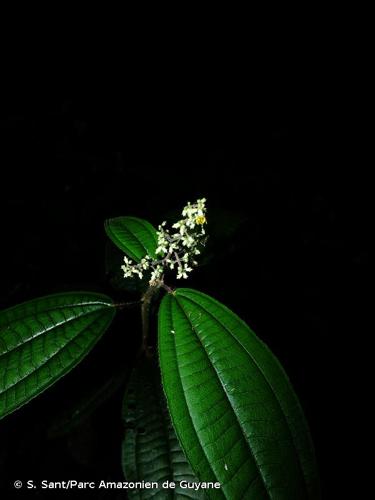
[121, 198, 207, 286]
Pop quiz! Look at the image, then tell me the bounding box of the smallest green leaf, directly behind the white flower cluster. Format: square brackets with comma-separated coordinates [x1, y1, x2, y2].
[104, 217, 157, 262]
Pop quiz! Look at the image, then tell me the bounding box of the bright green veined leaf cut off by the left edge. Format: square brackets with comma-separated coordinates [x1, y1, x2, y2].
[0, 292, 115, 418]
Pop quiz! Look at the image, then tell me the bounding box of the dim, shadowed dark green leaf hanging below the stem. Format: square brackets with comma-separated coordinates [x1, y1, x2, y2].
[122, 359, 203, 499]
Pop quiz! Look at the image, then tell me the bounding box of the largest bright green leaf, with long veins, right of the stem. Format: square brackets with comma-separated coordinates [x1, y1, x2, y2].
[159, 289, 320, 500]
